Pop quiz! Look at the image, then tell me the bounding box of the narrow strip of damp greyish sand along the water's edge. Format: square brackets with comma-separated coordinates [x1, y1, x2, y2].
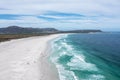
[38, 34, 63, 80]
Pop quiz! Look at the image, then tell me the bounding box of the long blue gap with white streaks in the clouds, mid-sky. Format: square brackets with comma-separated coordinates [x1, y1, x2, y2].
[38, 11, 85, 21]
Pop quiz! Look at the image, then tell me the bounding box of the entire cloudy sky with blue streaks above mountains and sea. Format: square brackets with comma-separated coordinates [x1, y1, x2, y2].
[0, 0, 120, 31]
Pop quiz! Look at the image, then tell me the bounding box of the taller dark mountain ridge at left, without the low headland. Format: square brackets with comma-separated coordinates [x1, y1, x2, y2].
[0, 26, 58, 34]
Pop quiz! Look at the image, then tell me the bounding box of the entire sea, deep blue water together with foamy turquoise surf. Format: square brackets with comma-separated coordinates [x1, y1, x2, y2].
[50, 33, 120, 80]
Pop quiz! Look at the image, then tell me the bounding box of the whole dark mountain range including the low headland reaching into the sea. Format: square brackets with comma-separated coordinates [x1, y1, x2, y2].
[0, 26, 102, 34]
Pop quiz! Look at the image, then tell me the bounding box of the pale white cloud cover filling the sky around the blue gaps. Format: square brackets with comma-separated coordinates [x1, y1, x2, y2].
[0, 0, 120, 28]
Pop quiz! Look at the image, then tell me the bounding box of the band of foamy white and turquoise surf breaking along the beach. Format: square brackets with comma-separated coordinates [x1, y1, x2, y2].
[51, 35, 104, 80]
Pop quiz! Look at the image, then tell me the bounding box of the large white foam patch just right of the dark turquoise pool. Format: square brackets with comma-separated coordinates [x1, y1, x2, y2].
[67, 55, 98, 71]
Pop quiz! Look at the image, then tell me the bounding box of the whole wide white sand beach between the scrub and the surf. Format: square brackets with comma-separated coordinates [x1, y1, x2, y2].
[0, 35, 60, 80]
